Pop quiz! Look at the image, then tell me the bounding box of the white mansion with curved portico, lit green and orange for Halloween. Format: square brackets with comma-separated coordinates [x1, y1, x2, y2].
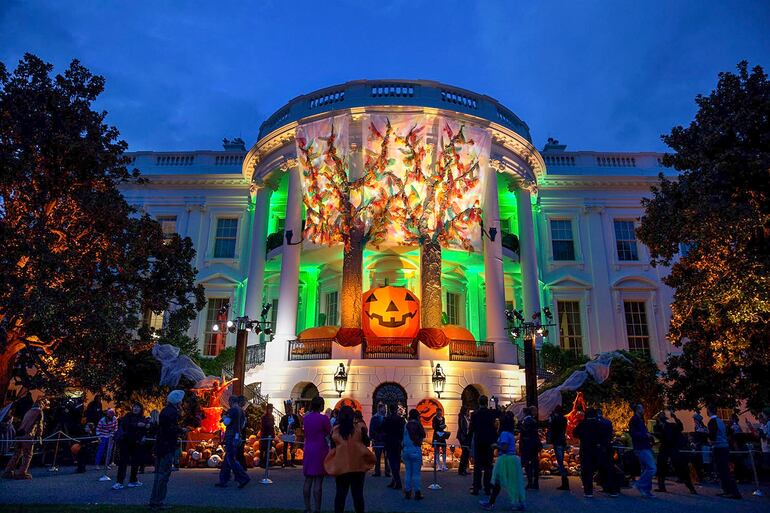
[124, 80, 672, 429]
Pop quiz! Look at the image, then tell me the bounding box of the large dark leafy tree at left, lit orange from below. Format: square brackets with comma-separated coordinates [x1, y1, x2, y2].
[0, 54, 204, 392]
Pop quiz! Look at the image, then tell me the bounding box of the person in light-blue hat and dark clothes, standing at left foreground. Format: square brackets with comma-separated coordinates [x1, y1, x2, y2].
[150, 390, 187, 509]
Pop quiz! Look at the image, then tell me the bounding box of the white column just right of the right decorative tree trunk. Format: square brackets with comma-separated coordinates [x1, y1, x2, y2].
[483, 166, 516, 364]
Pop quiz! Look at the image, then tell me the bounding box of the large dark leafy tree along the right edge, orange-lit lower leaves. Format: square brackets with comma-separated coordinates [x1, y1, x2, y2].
[638, 61, 770, 408]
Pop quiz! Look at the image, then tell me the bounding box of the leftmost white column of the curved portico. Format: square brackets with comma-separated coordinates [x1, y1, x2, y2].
[243, 186, 272, 344]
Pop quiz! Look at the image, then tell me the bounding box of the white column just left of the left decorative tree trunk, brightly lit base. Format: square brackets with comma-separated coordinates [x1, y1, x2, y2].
[265, 167, 302, 361]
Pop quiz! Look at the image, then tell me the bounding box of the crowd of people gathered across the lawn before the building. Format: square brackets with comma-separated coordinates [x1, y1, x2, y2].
[1, 390, 770, 513]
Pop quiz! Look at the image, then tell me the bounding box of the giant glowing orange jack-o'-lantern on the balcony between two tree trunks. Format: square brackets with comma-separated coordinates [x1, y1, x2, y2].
[361, 286, 420, 338]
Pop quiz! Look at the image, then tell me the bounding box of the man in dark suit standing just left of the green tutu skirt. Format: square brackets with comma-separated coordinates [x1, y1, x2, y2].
[468, 395, 500, 495]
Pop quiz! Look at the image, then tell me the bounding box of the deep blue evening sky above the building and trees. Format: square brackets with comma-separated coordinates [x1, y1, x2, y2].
[0, 0, 770, 151]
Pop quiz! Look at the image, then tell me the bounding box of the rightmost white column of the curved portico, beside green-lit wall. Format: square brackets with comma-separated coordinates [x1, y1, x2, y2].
[516, 188, 540, 322]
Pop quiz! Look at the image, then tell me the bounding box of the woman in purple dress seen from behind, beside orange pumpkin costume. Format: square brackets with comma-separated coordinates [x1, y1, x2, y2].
[302, 397, 332, 513]
